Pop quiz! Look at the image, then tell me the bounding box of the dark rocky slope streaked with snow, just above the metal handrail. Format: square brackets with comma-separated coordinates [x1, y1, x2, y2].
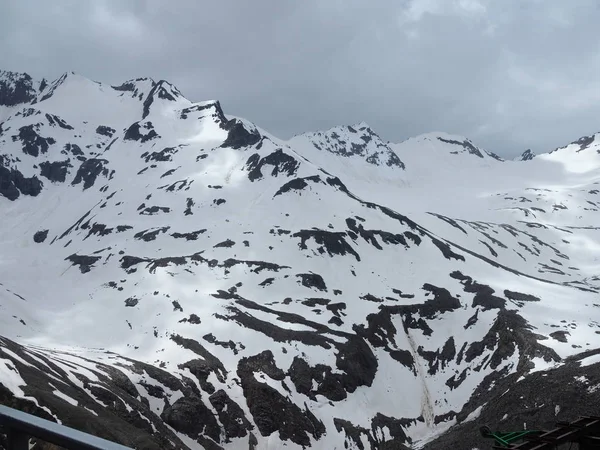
[0, 338, 185, 450]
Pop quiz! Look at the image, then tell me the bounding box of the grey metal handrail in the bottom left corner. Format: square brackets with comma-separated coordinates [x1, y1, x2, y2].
[0, 405, 131, 450]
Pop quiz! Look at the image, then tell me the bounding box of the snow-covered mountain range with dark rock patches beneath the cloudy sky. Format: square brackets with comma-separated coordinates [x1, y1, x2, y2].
[0, 68, 600, 449]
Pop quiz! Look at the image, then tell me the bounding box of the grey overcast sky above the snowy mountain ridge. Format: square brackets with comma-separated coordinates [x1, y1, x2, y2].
[0, 0, 600, 157]
